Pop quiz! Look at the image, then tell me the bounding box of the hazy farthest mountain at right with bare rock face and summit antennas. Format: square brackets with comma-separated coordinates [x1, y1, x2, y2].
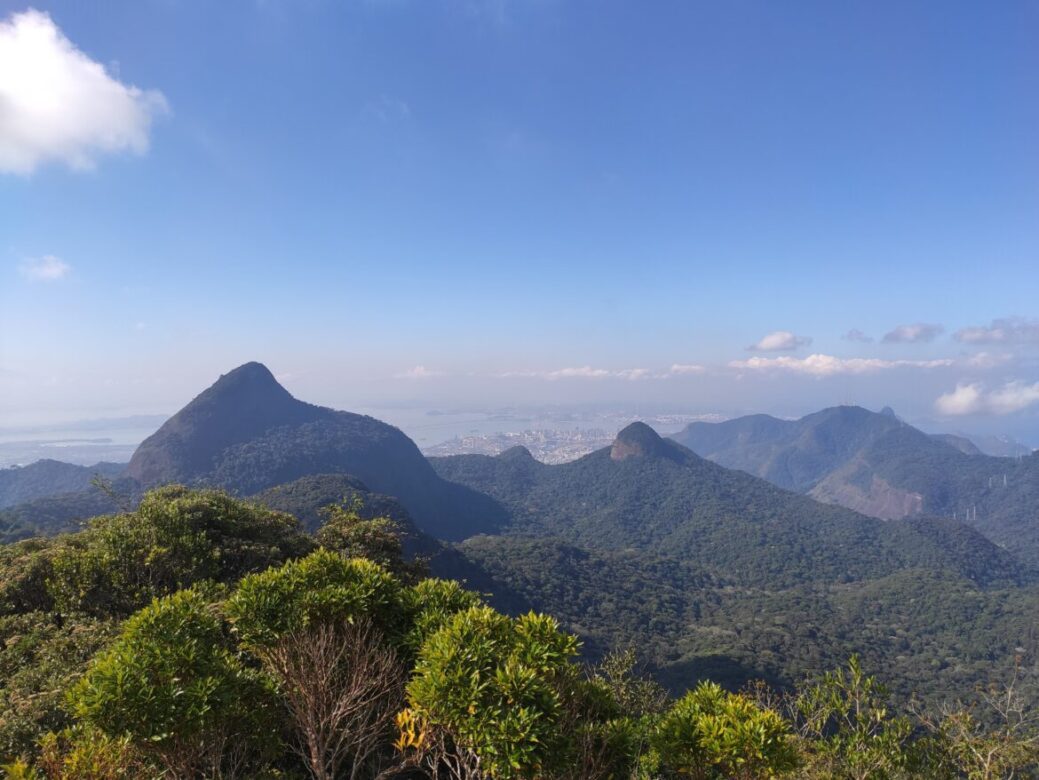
[672, 406, 1039, 566]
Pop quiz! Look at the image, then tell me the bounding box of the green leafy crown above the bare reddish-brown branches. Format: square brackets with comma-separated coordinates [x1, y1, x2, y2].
[228, 549, 405, 648]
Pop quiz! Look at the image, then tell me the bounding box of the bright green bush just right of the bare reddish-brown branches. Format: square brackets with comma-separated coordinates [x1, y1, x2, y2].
[407, 607, 577, 778]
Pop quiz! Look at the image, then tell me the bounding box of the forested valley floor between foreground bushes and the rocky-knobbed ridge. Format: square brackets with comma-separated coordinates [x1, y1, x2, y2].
[453, 536, 1039, 701]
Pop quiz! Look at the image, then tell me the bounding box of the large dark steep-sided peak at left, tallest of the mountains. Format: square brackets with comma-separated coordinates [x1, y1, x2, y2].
[119, 362, 497, 539]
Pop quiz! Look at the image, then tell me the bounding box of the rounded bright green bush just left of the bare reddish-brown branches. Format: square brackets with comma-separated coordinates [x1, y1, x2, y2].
[69, 590, 280, 774]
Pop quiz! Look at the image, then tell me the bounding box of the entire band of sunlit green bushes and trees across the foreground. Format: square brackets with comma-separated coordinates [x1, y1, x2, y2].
[0, 487, 1039, 780]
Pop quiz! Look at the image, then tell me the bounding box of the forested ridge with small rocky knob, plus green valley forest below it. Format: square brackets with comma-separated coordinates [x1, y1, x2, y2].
[432, 424, 1039, 699]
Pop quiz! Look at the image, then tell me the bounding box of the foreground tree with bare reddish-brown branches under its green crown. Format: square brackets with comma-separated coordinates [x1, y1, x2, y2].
[228, 549, 406, 780]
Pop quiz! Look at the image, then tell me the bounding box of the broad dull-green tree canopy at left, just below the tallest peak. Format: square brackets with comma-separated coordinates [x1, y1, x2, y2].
[49, 485, 314, 615]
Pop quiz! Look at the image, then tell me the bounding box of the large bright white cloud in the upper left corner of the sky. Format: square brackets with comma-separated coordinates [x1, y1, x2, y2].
[0, 9, 167, 174]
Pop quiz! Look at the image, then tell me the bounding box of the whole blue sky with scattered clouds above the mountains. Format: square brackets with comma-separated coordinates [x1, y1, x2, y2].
[0, 0, 1039, 443]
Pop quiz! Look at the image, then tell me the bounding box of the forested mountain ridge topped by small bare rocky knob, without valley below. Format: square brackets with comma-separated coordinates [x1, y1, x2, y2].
[431, 423, 1025, 587]
